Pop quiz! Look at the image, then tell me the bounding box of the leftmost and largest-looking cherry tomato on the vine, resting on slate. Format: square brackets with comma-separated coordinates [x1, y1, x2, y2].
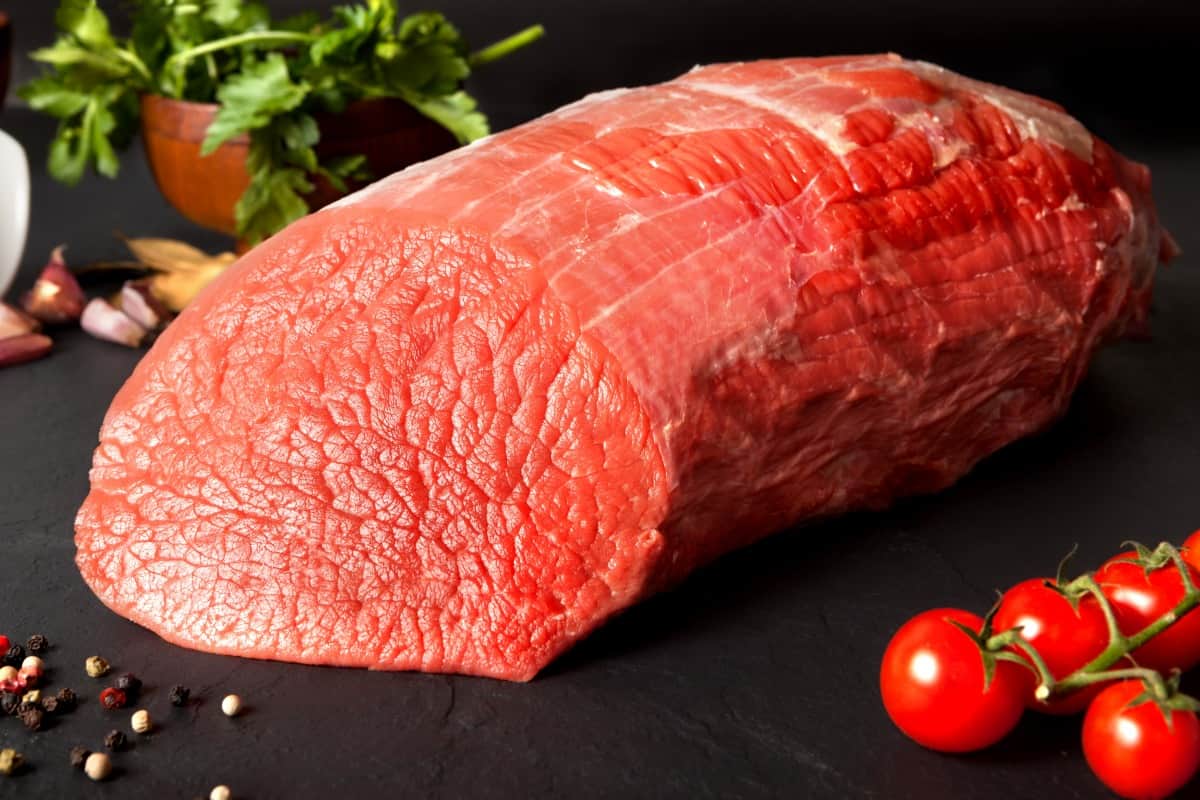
[880, 608, 1033, 753]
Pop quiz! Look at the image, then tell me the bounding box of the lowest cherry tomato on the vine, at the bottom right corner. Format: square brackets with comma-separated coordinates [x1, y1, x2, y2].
[1084, 680, 1200, 800]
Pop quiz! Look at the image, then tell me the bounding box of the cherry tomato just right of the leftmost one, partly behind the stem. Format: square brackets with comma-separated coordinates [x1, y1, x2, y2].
[991, 578, 1109, 714]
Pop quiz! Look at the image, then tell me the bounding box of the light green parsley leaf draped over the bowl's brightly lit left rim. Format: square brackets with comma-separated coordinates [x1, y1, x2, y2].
[200, 53, 308, 155]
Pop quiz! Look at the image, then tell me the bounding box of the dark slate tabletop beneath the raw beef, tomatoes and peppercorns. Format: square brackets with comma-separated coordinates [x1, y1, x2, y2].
[0, 31, 1200, 800]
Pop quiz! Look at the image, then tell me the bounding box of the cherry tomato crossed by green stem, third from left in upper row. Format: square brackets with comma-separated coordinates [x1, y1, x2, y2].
[1096, 553, 1200, 672]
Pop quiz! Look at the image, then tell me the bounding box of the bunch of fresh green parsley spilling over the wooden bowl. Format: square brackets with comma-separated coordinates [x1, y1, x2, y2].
[19, 0, 542, 242]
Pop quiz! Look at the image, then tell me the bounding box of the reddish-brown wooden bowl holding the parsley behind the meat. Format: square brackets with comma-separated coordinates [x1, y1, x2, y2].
[142, 95, 456, 236]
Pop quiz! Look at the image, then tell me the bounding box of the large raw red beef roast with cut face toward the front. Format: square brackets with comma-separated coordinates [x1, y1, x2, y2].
[77, 55, 1171, 680]
